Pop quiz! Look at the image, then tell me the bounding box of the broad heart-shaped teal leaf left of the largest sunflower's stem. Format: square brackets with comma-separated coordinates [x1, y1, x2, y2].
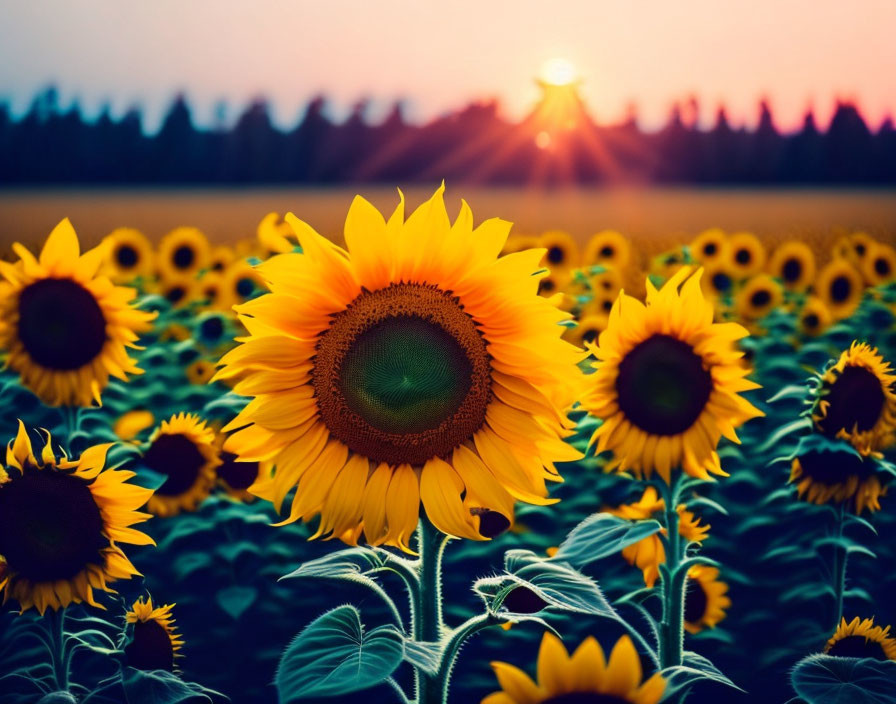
[275, 605, 404, 704]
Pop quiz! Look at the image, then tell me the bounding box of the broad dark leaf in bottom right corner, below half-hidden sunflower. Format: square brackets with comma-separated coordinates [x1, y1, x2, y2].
[790, 655, 896, 704]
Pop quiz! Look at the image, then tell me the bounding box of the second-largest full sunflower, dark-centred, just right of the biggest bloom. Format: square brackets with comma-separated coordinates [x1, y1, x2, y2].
[582, 267, 762, 481]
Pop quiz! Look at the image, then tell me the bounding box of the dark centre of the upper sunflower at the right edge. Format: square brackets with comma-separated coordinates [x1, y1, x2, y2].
[819, 366, 886, 436]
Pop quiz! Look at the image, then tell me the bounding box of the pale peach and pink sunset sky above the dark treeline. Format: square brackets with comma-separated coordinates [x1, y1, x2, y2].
[0, 0, 896, 129]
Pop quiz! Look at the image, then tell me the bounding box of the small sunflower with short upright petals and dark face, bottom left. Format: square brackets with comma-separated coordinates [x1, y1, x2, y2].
[123, 597, 184, 672]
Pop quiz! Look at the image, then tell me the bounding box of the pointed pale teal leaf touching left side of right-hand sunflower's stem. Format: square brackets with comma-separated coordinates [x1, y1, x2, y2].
[552, 513, 662, 567]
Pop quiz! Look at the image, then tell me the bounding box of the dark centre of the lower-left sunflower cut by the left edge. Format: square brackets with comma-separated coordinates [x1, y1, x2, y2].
[0, 468, 109, 582]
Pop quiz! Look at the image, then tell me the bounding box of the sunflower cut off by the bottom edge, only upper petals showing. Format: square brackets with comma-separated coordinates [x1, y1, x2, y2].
[482, 633, 666, 704]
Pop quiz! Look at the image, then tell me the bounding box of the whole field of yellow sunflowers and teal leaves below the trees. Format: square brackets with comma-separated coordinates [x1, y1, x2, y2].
[0, 186, 896, 704]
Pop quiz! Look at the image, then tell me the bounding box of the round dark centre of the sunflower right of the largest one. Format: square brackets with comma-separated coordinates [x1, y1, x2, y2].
[616, 335, 713, 435]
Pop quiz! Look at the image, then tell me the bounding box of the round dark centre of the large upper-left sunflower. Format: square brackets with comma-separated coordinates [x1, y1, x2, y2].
[19, 279, 106, 370]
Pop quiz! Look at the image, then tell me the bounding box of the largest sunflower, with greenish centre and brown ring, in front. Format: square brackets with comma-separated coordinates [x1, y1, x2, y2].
[216, 187, 583, 550]
